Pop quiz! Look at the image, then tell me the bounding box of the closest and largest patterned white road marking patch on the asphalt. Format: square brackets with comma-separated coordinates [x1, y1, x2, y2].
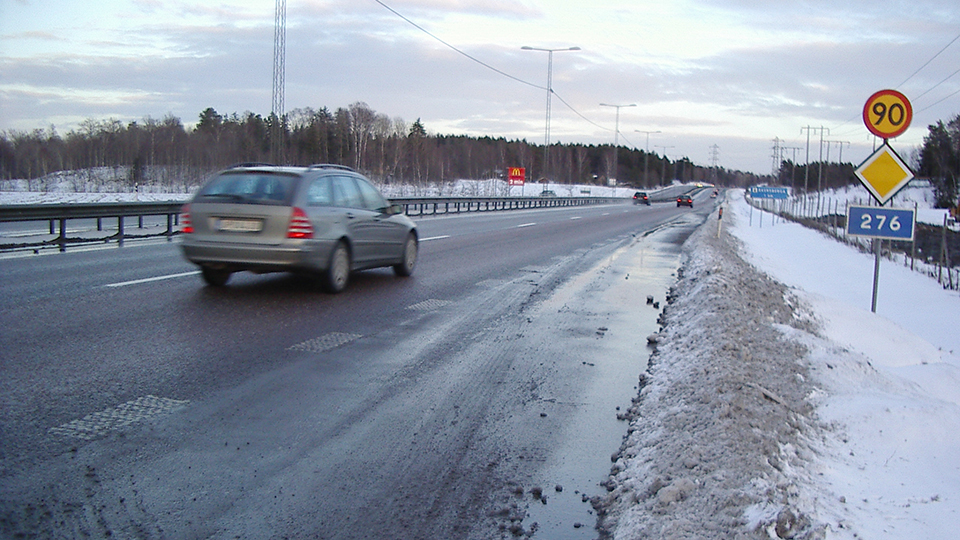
[49, 396, 190, 441]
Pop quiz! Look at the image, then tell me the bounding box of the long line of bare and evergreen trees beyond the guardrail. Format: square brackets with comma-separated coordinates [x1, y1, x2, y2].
[0, 102, 776, 192]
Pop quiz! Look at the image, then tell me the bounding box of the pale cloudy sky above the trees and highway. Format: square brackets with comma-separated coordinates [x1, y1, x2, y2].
[0, 0, 960, 173]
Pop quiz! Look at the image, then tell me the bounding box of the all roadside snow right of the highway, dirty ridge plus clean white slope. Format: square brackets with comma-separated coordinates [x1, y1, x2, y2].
[595, 191, 960, 540]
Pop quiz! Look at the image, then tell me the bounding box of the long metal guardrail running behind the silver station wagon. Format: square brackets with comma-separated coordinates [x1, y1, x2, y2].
[0, 197, 630, 251]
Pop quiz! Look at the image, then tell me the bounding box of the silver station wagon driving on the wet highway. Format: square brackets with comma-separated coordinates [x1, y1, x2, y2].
[180, 164, 419, 293]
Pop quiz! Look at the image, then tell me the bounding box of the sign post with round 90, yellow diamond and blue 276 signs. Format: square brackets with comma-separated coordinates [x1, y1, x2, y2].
[847, 90, 916, 313]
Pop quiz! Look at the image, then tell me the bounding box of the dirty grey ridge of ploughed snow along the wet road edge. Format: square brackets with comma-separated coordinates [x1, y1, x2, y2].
[597, 204, 825, 539]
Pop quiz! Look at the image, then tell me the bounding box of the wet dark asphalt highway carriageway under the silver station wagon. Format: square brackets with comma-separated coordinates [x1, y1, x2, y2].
[0, 194, 711, 539]
